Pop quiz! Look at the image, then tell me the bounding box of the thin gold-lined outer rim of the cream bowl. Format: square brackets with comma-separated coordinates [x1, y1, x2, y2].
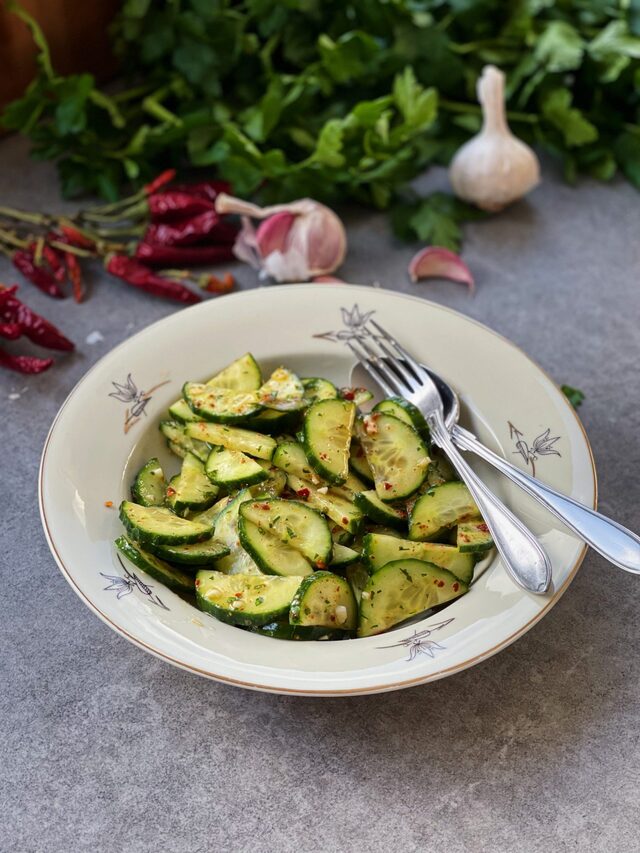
[38, 282, 598, 697]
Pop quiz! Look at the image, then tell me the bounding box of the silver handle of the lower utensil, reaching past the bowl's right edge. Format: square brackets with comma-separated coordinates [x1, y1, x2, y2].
[452, 427, 640, 575]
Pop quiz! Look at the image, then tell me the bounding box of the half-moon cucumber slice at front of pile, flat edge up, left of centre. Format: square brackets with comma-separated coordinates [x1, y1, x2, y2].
[195, 569, 302, 627]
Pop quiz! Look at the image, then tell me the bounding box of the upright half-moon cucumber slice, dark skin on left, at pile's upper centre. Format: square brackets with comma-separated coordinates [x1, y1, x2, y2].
[304, 400, 356, 486]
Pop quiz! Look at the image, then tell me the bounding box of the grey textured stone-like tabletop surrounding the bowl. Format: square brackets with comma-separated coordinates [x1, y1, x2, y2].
[0, 133, 640, 853]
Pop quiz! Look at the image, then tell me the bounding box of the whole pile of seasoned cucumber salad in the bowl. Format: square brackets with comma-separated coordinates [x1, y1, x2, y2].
[115, 353, 493, 640]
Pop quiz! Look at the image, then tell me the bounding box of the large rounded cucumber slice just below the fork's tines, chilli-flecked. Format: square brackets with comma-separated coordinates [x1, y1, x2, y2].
[356, 412, 430, 502]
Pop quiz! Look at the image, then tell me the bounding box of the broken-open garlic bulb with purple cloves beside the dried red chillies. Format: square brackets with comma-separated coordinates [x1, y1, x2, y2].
[215, 193, 347, 281]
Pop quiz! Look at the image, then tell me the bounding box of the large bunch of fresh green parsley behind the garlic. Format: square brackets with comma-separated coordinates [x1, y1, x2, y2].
[3, 0, 640, 248]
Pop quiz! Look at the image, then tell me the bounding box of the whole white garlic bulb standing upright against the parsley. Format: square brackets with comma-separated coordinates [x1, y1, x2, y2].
[449, 65, 540, 211]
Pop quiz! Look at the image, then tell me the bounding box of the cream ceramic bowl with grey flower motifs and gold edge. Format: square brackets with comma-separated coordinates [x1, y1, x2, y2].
[39, 284, 596, 696]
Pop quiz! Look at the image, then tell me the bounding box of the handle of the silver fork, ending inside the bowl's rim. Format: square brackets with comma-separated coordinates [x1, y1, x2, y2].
[427, 413, 551, 594]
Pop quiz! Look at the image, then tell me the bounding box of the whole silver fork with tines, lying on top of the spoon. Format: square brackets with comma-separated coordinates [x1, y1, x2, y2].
[346, 320, 551, 594]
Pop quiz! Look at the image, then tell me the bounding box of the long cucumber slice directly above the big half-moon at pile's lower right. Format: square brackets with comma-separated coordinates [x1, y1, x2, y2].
[362, 533, 475, 584]
